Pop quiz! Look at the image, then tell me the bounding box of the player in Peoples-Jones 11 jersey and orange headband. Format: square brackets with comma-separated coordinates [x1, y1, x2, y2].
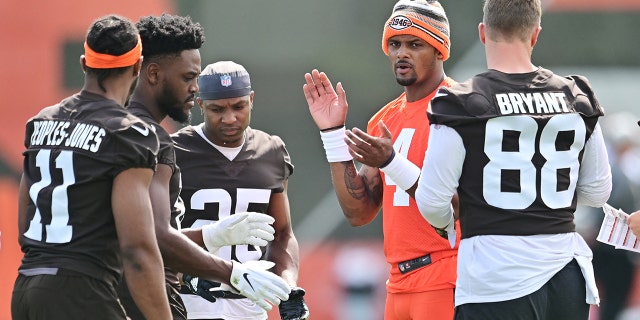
[13, 15, 170, 320]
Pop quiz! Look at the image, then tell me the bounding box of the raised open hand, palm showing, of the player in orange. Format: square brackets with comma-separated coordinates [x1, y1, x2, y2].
[302, 69, 348, 130]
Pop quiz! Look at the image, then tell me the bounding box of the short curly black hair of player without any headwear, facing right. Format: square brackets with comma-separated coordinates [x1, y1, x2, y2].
[136, 13, 205, 63]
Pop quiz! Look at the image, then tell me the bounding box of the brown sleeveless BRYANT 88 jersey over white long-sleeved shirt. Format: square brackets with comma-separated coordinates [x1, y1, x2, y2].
[429, 68, 604, 238]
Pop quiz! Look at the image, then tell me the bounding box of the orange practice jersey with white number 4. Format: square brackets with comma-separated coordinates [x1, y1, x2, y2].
[367, 78, 460, 293]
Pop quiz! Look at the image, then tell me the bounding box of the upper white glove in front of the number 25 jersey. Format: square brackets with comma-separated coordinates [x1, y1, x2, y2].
[202, 212, 275, 253]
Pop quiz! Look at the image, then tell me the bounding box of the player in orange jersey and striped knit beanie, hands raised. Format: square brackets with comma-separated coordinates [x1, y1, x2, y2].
[303, 0, 457, 320]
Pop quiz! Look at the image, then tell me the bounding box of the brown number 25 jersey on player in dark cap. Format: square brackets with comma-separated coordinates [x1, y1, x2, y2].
[172, 126, 293, 262]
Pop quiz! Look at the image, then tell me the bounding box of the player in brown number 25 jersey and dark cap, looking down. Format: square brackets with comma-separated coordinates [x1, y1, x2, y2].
[172, 61, 309, 320]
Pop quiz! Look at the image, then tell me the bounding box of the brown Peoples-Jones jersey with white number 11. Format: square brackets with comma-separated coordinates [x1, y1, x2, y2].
[20, 91, 158, 285]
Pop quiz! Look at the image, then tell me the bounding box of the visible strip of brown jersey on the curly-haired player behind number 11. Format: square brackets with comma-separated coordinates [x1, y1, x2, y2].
[127, 102, 183, 288]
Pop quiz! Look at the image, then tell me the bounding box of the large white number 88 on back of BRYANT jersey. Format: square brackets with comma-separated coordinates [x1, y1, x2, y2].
[482, 113, 586, 209]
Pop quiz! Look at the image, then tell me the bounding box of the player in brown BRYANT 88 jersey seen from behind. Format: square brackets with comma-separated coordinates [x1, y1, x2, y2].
[416, 0, 611, 320]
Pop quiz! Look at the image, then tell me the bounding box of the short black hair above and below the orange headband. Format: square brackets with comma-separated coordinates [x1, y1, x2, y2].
[86, 14, 138, 92]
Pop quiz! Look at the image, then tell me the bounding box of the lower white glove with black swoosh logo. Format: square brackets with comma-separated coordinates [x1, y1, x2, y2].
[229, 260, 291, 311]
